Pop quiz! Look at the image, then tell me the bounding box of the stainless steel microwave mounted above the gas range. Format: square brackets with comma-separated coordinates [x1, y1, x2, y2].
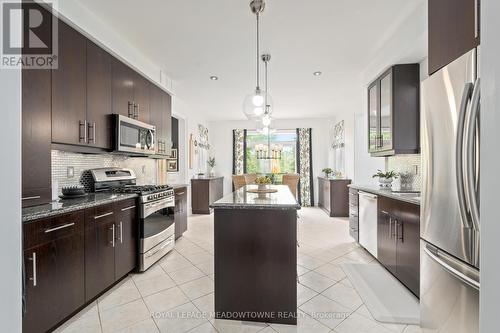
[114, 115, 156, 155]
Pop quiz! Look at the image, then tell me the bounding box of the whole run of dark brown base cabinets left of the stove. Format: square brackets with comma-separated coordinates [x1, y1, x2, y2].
[23, 199, 138, 333]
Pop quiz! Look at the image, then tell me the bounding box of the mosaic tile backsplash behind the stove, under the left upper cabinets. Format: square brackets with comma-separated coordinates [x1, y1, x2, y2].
[52, 150, 156, 197]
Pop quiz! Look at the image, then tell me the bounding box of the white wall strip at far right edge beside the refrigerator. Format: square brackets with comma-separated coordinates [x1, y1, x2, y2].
[480, 0, 500, 333]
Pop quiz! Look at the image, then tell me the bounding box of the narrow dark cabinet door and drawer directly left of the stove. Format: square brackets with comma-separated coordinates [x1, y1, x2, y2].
[115, 199, 139, 280]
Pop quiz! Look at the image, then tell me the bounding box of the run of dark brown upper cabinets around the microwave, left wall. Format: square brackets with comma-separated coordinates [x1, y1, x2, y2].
[22, 5, 172, 207]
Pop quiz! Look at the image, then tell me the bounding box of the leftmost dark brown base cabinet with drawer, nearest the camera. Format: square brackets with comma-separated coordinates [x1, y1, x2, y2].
[23, 211, 85, 333]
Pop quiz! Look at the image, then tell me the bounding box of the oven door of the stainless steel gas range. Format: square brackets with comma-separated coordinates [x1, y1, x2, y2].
[140, 199, 175, 253]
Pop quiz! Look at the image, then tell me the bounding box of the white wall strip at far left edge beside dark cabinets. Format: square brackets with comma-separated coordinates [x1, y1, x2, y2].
[0, 9, 22, 332]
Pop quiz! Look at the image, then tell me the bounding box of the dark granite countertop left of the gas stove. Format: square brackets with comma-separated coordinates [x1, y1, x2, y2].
[22, 192, 137, 223]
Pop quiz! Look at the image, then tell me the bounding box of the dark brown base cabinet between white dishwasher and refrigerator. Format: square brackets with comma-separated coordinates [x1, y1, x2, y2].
[376, 196, 420, 297]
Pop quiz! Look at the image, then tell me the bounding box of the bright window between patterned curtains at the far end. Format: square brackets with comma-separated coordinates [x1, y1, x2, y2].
[246, 130, 297, 183]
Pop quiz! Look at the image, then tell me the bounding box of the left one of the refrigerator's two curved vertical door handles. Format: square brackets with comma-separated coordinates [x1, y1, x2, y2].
[455, 82, 474, 229]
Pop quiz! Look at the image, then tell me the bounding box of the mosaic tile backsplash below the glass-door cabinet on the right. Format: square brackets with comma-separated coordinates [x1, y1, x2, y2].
[385, 155, 422, 190]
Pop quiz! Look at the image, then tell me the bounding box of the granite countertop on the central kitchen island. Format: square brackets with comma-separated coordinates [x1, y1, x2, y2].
[210, 185, 300, 209]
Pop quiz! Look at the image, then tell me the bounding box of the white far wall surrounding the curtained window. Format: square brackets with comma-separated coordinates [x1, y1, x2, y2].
[209, 119, 333, 202]
